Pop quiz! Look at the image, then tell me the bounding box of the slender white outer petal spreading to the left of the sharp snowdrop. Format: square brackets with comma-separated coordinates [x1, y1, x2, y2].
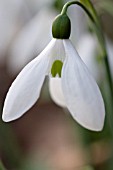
[2, 39, 56, 122]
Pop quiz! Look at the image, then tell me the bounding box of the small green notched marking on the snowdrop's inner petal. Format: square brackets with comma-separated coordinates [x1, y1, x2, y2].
[51, 60, 63, 77]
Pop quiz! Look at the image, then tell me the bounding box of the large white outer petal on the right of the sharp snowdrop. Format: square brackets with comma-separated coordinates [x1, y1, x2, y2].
[62, 40, 105, 131]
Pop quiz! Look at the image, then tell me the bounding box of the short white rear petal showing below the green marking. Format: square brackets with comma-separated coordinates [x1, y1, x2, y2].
[49, 77, 66, 107]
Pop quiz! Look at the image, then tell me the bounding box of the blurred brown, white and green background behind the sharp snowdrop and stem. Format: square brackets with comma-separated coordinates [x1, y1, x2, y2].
[0, 0, 113, 170]
